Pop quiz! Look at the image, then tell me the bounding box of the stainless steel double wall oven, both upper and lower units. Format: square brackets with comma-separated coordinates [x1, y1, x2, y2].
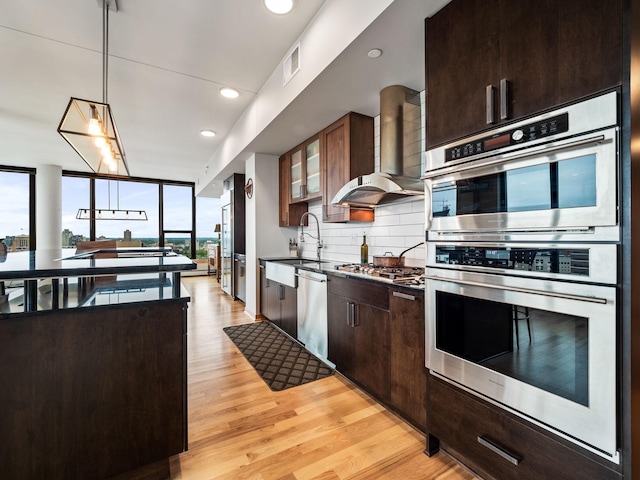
[424, 92, 620, 463]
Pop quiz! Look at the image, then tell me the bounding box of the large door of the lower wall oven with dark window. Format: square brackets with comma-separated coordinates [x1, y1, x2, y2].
[425, 268, 617, 461]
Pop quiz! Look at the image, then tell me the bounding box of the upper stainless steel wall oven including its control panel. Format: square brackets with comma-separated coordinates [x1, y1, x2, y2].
[423, 93, 619, 241]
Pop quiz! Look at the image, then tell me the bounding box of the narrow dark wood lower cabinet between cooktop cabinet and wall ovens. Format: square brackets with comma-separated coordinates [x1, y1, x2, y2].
[389, 287, 427, 431]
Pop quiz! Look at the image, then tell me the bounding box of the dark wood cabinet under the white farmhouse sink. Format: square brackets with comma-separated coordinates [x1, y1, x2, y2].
[260, 263, 298, 338]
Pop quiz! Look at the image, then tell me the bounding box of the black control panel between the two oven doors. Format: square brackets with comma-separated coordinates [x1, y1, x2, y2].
[435, 245, 589, 277]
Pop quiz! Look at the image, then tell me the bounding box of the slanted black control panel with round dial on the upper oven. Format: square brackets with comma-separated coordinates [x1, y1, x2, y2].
[444, 113, 569, 162]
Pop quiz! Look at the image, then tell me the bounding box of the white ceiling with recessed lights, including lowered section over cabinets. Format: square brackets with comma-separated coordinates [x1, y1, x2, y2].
[0, 0, 446, 195]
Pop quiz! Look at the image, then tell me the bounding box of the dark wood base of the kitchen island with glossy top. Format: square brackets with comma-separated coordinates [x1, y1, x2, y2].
[0, 298, 187, 479]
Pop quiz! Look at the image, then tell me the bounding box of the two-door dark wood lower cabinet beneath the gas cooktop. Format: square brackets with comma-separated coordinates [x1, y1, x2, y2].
[328, 275, 391, 403]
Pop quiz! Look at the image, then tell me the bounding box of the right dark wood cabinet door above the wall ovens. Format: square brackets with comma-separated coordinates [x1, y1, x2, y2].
[500, 0, 622, 120]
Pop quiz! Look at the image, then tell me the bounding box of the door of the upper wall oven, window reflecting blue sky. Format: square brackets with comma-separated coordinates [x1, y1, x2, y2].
[425, 128, 618, 240]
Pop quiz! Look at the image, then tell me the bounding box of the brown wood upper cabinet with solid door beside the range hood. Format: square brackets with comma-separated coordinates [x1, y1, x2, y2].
[321, 112, 374, 222]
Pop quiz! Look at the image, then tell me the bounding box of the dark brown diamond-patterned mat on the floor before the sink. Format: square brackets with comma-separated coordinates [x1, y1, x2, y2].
[223, 322, 333, 391]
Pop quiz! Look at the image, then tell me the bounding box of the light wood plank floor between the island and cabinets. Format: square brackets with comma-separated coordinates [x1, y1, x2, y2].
[171, 277, 475, 480]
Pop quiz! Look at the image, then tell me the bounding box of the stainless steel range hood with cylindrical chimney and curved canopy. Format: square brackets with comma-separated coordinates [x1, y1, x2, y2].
[331, 85, 424, 207]
